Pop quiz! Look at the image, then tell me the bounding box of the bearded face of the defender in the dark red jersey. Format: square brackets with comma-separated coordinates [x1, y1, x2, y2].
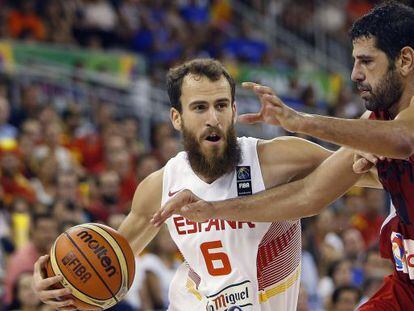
[351, 37, 401, 111]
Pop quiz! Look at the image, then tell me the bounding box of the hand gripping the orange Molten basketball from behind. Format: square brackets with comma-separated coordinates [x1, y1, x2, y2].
[33, 255, 76, 311]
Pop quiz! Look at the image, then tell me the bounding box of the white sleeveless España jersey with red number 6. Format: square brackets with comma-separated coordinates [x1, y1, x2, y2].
[162, 137, 301, 311]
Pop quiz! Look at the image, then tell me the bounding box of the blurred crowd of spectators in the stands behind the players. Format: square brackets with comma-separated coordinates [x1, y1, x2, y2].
[0, 0, 392, 311]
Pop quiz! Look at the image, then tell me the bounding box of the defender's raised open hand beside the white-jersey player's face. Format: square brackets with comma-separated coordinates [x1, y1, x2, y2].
[239, 82, 303, 132]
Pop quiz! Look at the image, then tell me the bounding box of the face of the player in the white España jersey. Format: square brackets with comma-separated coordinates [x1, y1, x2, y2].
[172, 74, 236, 156]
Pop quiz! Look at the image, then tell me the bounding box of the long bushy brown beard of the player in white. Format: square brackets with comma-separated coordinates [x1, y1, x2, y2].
[183, 125, 241, 180]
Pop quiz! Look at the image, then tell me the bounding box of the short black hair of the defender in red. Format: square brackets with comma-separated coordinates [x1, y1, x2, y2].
[349, 1, 414, 66]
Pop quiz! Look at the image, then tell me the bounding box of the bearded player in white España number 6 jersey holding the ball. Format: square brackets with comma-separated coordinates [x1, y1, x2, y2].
[34, 59, 376, 311]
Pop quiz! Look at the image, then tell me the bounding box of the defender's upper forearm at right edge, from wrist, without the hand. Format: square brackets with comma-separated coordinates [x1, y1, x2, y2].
[297, 114, 414, 159]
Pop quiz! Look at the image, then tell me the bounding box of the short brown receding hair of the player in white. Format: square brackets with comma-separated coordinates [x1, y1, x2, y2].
[167, 58, 236, 112]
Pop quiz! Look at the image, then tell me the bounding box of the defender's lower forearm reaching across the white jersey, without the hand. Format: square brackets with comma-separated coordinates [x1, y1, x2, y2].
[211, 149, 360, 221]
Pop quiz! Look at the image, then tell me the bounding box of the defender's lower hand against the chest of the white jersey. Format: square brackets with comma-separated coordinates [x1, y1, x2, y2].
[150, 189, 213, 227]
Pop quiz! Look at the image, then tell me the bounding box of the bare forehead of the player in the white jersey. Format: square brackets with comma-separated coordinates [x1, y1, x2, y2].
[181, 74, 231, 104]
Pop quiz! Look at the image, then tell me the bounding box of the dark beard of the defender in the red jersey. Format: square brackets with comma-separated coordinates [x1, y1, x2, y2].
[364, 68, 403, 111]
